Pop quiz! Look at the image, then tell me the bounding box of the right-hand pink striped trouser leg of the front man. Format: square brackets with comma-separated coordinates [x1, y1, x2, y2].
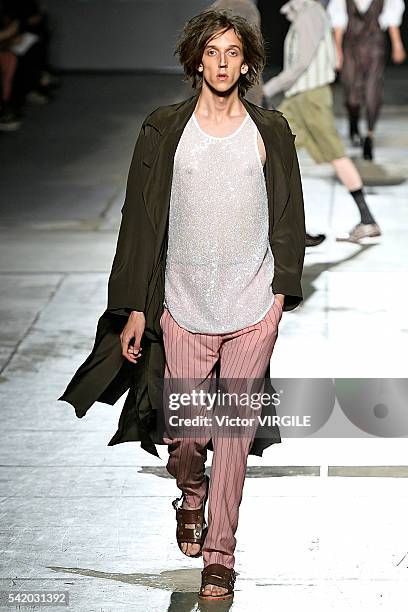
[203, 301, 282, 594]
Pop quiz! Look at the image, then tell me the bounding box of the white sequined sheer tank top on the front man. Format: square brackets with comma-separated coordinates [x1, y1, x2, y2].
[164, 113, 274, 334]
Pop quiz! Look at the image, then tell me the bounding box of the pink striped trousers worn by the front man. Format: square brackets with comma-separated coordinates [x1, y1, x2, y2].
[160, 300, 282, 568]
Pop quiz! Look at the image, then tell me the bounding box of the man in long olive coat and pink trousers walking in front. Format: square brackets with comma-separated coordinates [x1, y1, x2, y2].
[60, 11, 305, 599]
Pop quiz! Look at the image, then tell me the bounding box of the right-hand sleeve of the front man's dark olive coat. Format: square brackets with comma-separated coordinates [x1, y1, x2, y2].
[271, 121, 306, 311]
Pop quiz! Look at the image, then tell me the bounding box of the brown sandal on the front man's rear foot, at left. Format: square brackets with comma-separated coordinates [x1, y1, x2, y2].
[172, 475, 210, 559]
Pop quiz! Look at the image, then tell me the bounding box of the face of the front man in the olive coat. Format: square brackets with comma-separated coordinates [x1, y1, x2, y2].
[198, 29, 248, 93]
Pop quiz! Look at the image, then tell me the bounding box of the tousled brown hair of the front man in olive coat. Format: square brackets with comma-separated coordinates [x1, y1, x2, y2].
[174, 10, 266, 96]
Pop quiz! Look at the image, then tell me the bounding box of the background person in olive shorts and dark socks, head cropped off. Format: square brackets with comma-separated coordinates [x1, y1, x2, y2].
[264, 0, 381, 242]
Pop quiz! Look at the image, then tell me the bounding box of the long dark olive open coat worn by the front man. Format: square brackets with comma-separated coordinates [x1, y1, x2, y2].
[58, 94, 305, 456]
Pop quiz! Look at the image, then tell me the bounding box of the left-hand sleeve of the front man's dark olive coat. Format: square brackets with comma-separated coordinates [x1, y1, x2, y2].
[107, 123, 155, 316]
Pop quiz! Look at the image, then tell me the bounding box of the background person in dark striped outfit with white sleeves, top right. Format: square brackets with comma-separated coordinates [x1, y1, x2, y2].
[327, 0, 406, 160]
